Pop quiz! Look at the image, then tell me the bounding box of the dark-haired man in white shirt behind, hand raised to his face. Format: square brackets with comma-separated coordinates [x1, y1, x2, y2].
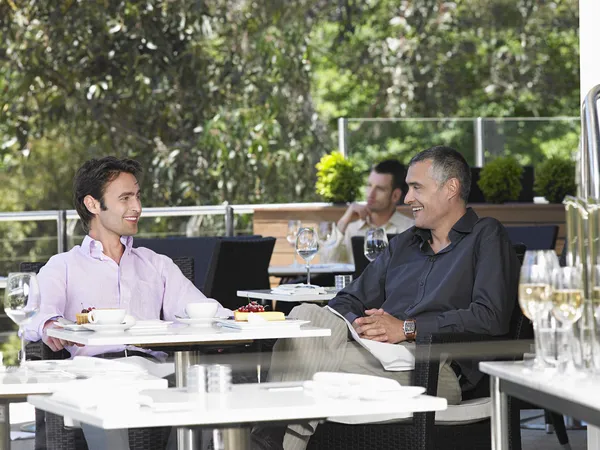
[320, 159, 414, 263]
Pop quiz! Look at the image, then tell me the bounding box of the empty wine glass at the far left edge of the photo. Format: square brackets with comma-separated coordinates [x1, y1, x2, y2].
[4, 272, 40, 366]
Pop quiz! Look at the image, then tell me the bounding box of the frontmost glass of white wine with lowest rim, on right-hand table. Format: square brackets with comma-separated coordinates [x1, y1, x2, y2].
[552, 266, 584, 373]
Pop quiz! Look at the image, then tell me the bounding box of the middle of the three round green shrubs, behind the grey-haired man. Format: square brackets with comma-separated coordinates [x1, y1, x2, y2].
[477, 156, 523, 203]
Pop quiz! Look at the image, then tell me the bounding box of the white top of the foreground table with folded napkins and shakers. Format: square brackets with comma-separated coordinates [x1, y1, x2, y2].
[27, 383, 447, 429]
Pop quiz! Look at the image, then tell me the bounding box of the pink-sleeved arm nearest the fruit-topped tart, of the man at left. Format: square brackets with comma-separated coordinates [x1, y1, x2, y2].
[156, 254, 233, 320]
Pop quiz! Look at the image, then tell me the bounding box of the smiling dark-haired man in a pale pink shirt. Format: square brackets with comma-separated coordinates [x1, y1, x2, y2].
[25, 156, 232, 449]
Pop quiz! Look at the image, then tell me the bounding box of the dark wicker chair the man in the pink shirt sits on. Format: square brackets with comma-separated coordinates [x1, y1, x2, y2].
[20, 257, 194, 450]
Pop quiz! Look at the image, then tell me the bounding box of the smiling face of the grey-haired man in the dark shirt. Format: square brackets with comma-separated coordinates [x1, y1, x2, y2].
[404, 160, 453, 230]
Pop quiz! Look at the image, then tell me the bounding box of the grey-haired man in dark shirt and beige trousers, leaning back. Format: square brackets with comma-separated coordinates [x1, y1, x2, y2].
[253, 146, 519, 450]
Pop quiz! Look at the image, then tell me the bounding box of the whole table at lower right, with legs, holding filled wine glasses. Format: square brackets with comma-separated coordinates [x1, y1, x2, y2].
[479, 361, 600, 450]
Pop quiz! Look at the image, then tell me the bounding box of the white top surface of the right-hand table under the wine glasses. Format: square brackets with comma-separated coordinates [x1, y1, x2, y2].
[479, 361, 600, 411]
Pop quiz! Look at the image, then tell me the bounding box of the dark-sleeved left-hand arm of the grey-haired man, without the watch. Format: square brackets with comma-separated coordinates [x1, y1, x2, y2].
[329, 243, 392, 323]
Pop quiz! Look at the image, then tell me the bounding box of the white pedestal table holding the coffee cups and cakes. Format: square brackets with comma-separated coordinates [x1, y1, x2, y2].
[47, 324, 331, 450]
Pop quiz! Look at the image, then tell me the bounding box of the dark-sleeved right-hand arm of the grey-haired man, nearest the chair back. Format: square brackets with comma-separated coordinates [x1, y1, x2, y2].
[416, 224, 519, 336]
